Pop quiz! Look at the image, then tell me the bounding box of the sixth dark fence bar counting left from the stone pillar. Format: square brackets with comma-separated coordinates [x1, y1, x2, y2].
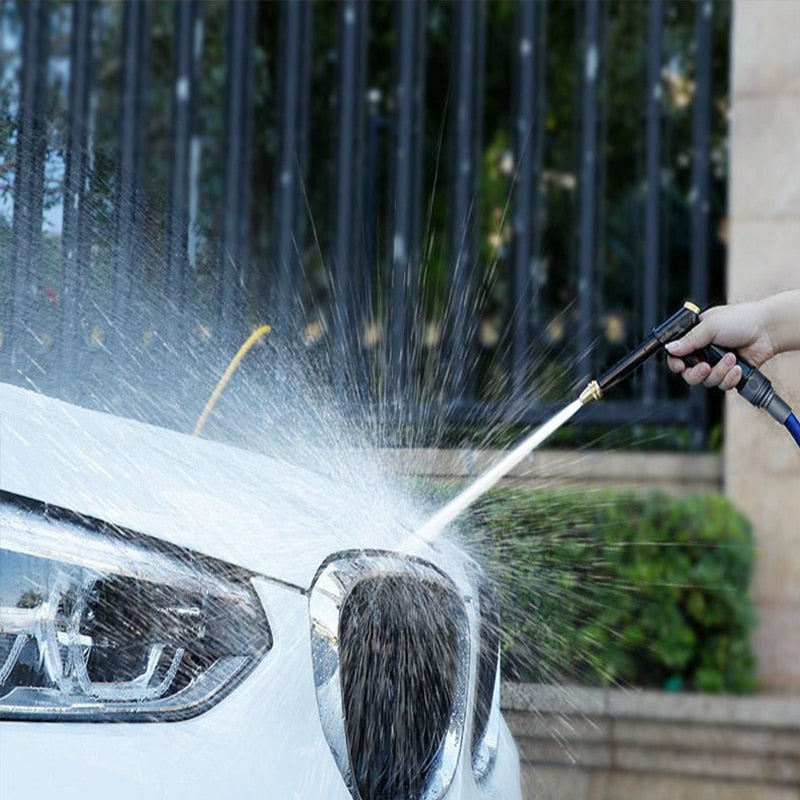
[389, 2, 426, 410]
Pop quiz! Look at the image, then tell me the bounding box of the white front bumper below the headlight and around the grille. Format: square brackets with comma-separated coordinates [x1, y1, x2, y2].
[0, 579, 521, 800]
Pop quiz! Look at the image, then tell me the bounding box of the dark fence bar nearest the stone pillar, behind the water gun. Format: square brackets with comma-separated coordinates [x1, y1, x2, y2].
[690, 0, 713, 449]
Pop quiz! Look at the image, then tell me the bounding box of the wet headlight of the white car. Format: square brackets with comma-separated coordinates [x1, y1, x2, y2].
[0, 493, 272, 721]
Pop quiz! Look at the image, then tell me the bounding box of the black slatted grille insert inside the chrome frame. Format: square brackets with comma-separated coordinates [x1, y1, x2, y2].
[339, 575, 463, 800]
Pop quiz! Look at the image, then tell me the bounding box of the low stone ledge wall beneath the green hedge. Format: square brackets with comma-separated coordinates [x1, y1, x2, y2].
[502, 684, 800, 800]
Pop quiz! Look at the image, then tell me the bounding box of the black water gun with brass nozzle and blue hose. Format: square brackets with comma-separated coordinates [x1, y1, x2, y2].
[580, 302, 800, 445]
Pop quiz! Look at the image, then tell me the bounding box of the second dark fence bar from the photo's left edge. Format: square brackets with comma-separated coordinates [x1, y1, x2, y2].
[59, 0, 95, 388]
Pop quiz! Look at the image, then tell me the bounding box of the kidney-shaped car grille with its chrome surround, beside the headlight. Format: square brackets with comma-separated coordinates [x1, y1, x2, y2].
[310, 552, 469, 800]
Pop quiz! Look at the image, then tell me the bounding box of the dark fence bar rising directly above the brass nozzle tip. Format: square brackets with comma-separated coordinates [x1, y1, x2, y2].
[577, 0, 600, 382]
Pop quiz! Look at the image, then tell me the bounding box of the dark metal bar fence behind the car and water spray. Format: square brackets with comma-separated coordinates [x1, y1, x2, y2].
[0, 0, 731, 446]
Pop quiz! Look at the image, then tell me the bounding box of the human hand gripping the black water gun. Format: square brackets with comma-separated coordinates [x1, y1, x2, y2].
[666, 302, 776, 390]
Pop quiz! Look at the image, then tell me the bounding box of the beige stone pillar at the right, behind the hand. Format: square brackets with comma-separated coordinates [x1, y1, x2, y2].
[724, 0, 800, 692]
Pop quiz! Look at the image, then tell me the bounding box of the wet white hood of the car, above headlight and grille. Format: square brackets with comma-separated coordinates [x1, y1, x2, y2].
[0, 384, 436, 588]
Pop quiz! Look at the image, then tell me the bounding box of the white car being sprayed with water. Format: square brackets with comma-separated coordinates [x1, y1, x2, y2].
[0, 385, 521, 800]
